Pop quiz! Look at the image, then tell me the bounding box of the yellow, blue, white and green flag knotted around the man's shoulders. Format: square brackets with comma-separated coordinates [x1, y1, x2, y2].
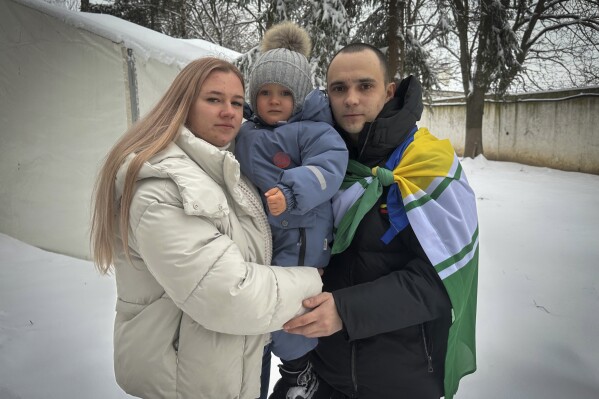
[332, 128, 478, 399]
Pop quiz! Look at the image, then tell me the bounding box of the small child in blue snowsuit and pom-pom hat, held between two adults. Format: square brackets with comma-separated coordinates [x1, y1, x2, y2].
[235, 23, 348, 399]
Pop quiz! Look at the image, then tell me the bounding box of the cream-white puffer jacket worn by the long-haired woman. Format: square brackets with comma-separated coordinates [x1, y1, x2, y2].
[114, 128, 322, 399]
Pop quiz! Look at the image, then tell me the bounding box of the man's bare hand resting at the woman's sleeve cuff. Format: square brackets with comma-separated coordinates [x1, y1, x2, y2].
[283, 292, 343, 338]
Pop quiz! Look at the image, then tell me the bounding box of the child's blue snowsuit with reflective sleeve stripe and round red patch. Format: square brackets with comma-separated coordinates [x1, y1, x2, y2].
[235, 90, 348, 360]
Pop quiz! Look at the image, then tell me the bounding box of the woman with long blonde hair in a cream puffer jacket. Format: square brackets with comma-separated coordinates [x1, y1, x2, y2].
[91, 58, 322, 398]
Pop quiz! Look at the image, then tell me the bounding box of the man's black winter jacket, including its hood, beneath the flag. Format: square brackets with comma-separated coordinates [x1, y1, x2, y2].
[311, 77, 451, 399]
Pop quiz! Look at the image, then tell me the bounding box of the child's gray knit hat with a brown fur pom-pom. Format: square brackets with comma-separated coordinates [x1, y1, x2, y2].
[249, 22, 313, 115]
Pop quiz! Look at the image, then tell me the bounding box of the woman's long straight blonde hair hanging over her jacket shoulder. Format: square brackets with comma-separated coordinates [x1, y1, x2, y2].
[90, 57, 244, 274]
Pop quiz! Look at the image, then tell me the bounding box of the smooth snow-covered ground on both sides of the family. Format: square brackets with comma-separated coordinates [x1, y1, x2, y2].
[0, 157, 599, 399]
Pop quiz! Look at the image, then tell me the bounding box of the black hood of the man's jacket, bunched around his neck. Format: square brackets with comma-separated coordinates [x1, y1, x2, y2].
[335, 75, 424, 166]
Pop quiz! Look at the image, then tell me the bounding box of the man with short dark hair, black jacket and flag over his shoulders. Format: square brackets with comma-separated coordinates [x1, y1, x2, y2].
[284, 43, 478, 399]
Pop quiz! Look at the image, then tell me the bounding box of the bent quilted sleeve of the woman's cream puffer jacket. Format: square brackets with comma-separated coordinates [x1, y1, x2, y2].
[133, 202, 322, 335]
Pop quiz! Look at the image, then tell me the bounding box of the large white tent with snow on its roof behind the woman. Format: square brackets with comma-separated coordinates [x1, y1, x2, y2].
[0, 0, 239, 258]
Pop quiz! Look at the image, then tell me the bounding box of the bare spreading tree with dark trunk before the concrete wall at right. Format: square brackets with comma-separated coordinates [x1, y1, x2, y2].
[439, 0, 599, 157]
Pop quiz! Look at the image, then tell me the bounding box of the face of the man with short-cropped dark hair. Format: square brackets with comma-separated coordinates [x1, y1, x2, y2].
[327, 50, 395, 139]
